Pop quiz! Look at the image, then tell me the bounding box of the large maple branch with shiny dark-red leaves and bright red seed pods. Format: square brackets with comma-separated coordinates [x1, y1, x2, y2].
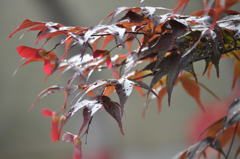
[9, 0, 240, 158]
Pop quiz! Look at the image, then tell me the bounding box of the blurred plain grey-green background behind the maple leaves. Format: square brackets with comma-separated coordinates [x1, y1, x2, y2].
[0, 0, 239, 159]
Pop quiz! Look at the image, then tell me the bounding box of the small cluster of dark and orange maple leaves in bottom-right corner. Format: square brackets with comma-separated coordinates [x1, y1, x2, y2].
[176, 98, 240, 159]
